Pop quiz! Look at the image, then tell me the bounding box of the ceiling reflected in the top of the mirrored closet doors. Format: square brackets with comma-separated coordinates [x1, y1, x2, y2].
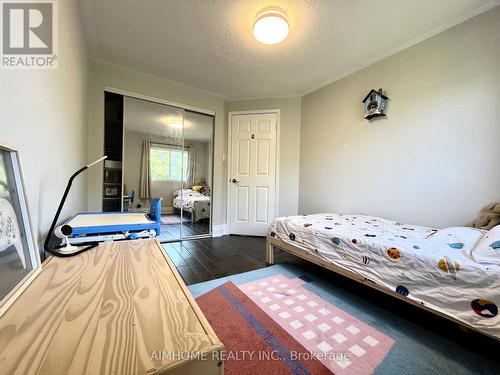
[123, 96, 213, 142]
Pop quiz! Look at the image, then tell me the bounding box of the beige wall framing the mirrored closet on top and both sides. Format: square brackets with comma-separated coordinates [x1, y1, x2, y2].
[88, 62, 227, 225]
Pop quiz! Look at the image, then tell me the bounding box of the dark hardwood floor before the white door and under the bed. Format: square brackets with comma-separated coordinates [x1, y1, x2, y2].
[163, 236, 500, 361]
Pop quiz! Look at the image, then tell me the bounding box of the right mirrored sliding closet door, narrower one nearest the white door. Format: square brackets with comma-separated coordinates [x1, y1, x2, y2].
[182, 110, 214, 238]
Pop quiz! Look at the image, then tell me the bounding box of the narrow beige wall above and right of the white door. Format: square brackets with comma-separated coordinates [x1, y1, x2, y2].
[226, 98, 301, 216]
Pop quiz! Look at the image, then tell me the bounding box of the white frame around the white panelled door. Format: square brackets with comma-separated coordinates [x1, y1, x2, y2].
[226, 109, 281, 234]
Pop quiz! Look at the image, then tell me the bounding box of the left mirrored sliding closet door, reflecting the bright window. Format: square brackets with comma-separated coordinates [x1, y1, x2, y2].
[123, 97, 187, 242]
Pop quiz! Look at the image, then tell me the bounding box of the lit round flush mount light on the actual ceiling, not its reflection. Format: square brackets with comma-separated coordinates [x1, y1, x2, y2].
[253, 7, 290, 44]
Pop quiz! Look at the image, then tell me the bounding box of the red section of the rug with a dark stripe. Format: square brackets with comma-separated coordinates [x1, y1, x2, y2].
[197, 282, 330, 375]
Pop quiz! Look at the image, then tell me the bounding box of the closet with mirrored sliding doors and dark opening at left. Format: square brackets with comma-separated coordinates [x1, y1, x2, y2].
[103, 93, 214, 242]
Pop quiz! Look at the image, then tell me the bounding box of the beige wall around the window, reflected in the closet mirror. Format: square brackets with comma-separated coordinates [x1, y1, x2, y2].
[123, 131, 211, 212]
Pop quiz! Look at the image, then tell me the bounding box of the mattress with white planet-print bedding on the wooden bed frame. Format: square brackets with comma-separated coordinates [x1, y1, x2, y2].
[269, 214, 500, 338]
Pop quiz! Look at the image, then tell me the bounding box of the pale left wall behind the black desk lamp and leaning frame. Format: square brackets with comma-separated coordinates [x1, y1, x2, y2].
[0, 0, 88, 247]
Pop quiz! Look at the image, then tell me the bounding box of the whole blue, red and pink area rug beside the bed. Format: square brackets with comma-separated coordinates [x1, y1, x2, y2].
[189, 264, 500, 375]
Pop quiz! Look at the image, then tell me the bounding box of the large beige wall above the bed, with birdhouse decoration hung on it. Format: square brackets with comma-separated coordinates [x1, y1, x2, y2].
[299, 7, 500, 227]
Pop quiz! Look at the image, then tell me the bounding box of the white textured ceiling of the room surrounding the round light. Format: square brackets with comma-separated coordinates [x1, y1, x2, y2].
[79, 0, 500, 99]
